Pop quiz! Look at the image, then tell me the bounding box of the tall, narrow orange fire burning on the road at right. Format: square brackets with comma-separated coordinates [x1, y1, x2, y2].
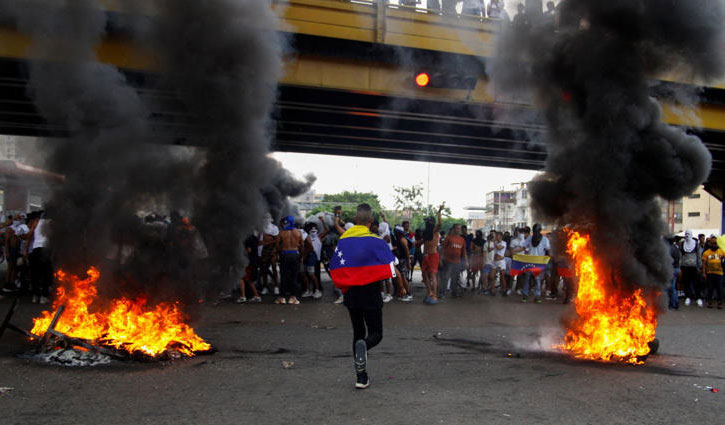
[562, 231, 657, 364]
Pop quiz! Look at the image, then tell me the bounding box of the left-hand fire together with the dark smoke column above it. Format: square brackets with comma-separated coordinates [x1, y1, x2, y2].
[0, 0, 314, 357]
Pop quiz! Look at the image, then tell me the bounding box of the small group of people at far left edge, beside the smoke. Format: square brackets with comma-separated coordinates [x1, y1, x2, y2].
[0, 211, 53, 304]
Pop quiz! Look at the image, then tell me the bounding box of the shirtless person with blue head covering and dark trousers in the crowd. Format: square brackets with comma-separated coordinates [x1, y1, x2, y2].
[274, 215, 302, 304]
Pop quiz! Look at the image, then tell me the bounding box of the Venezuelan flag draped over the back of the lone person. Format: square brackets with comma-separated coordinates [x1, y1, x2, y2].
[330, 226, 395, 293]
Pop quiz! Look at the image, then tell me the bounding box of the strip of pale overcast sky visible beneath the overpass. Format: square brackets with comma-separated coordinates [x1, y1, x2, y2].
[272, 152, 535, 218]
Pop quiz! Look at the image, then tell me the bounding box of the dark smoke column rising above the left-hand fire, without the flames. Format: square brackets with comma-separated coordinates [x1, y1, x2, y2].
[0, 0, 314, 298]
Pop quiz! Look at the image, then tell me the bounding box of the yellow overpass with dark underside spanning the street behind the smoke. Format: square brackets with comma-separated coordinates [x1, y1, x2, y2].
[0, 0, 725, 199]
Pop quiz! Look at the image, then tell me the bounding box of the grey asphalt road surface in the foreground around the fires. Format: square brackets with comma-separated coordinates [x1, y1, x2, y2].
[0, 274, 725, 425]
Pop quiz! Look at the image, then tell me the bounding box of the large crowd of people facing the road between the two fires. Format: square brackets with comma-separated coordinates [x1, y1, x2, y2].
[236, 206, 574, 305]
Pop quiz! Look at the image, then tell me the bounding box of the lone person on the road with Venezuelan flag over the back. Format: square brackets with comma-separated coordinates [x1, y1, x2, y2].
[330, 204, 400, 389]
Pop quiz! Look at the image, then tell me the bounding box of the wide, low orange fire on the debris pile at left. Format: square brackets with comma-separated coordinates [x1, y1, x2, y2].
[31, 267, 211, 357]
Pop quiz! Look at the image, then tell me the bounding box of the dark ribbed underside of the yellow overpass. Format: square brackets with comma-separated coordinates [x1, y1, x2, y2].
[0, 60, 725, 199]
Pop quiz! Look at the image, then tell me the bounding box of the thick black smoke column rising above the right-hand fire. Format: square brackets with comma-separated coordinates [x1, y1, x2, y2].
[494, 0, 724, 286]
